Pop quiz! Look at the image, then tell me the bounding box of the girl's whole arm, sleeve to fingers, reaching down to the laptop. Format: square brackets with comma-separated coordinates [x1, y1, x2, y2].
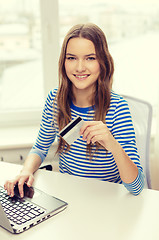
[4, 89, 56, 197]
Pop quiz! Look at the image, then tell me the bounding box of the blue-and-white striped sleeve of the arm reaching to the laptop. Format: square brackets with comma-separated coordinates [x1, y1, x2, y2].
[30, 92, 56, 162]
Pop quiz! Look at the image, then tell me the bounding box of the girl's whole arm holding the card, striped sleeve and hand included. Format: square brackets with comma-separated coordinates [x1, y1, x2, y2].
[81, 95, 144, 195]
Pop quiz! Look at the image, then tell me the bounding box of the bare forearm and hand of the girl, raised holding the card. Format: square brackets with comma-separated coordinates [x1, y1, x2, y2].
[81, 121, 138, 183]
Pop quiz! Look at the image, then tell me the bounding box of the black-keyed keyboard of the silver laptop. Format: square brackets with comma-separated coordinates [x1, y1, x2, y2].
[0, 187, 45, 225]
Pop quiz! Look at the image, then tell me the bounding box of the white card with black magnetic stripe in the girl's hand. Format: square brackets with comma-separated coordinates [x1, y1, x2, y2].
[59, 117, 84, 145]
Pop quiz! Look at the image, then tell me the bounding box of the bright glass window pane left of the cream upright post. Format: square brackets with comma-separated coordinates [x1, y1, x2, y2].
[0, 0, 43, 111]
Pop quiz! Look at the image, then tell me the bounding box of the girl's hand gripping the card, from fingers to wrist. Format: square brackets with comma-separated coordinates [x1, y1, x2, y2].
[80, 121, 115, 150]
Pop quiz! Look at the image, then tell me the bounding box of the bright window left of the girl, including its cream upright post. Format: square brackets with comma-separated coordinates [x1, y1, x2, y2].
[0, 0, 59, 126]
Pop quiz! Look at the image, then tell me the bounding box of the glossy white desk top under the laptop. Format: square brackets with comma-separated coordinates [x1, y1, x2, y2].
[0, 163, 159, 240]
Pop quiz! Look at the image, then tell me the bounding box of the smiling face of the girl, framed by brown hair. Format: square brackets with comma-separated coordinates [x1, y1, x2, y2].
[65, 38, 100, 94]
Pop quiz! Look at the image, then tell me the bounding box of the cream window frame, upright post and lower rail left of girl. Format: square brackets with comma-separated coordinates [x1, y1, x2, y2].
[0, 0, 59, 128]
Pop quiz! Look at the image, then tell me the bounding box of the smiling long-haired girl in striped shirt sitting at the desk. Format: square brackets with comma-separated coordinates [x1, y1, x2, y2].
[5, 24, 144, 195]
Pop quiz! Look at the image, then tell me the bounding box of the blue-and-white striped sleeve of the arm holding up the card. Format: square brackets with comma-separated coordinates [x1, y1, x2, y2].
[112, 97, 145, 195]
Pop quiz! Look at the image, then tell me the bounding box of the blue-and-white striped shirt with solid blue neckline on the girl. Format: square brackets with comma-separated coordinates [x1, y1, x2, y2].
[30, 89, 144, 195]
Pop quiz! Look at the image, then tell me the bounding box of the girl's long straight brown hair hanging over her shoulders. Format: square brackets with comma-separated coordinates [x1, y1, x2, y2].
[57, 24, 114, 152]
